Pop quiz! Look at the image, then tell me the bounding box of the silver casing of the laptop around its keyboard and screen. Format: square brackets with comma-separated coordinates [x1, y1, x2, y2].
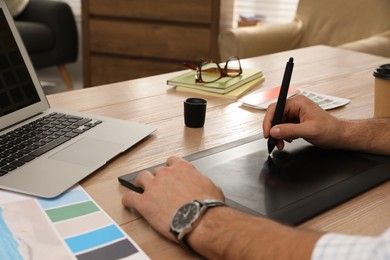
[0, 0, 156, 198]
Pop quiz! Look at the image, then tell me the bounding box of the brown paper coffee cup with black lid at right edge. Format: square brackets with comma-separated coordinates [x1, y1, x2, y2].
[373, 64, 390, 117]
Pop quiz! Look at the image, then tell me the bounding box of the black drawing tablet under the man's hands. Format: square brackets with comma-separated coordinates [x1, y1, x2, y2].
[119, 135, 390, 225]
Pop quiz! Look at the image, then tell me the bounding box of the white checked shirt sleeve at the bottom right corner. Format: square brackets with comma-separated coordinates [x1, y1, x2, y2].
[312, 228, 390, 260]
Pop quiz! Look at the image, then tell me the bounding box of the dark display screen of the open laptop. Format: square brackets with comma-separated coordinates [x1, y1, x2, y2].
[0, 9, 40, 116]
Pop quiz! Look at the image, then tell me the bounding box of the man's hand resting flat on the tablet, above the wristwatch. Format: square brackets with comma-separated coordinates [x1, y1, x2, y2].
[122, 156, 224, 241]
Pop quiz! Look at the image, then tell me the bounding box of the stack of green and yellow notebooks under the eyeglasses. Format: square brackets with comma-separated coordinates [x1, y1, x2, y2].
[167, 68, 264, 100]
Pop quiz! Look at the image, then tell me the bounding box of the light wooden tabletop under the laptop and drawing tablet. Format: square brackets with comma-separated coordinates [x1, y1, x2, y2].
[48, 46, 390, 259]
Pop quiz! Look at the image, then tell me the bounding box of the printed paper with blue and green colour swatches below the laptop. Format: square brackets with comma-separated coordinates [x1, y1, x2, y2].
[0, 185, 149, 260]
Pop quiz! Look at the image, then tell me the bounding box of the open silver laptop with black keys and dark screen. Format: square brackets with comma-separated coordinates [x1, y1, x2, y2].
[0, 1, 156, 198]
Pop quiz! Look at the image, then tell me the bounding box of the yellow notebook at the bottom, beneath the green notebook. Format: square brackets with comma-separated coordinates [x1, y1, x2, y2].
[176, 76, 264, 100]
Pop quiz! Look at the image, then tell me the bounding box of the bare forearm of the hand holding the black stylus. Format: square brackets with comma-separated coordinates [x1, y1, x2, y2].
[335, 119, 390, 155]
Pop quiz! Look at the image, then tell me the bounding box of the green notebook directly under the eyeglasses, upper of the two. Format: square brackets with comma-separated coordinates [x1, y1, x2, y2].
[167, 68, 263, 94]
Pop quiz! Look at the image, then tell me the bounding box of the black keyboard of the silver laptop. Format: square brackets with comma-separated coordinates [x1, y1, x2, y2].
[0, 113, 102, 176]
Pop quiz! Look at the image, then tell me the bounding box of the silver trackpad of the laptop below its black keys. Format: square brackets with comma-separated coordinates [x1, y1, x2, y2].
[50, 137, 123, 167]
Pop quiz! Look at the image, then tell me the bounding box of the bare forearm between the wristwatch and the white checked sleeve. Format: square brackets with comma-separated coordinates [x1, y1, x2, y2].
[188, 207, 321, 259]
